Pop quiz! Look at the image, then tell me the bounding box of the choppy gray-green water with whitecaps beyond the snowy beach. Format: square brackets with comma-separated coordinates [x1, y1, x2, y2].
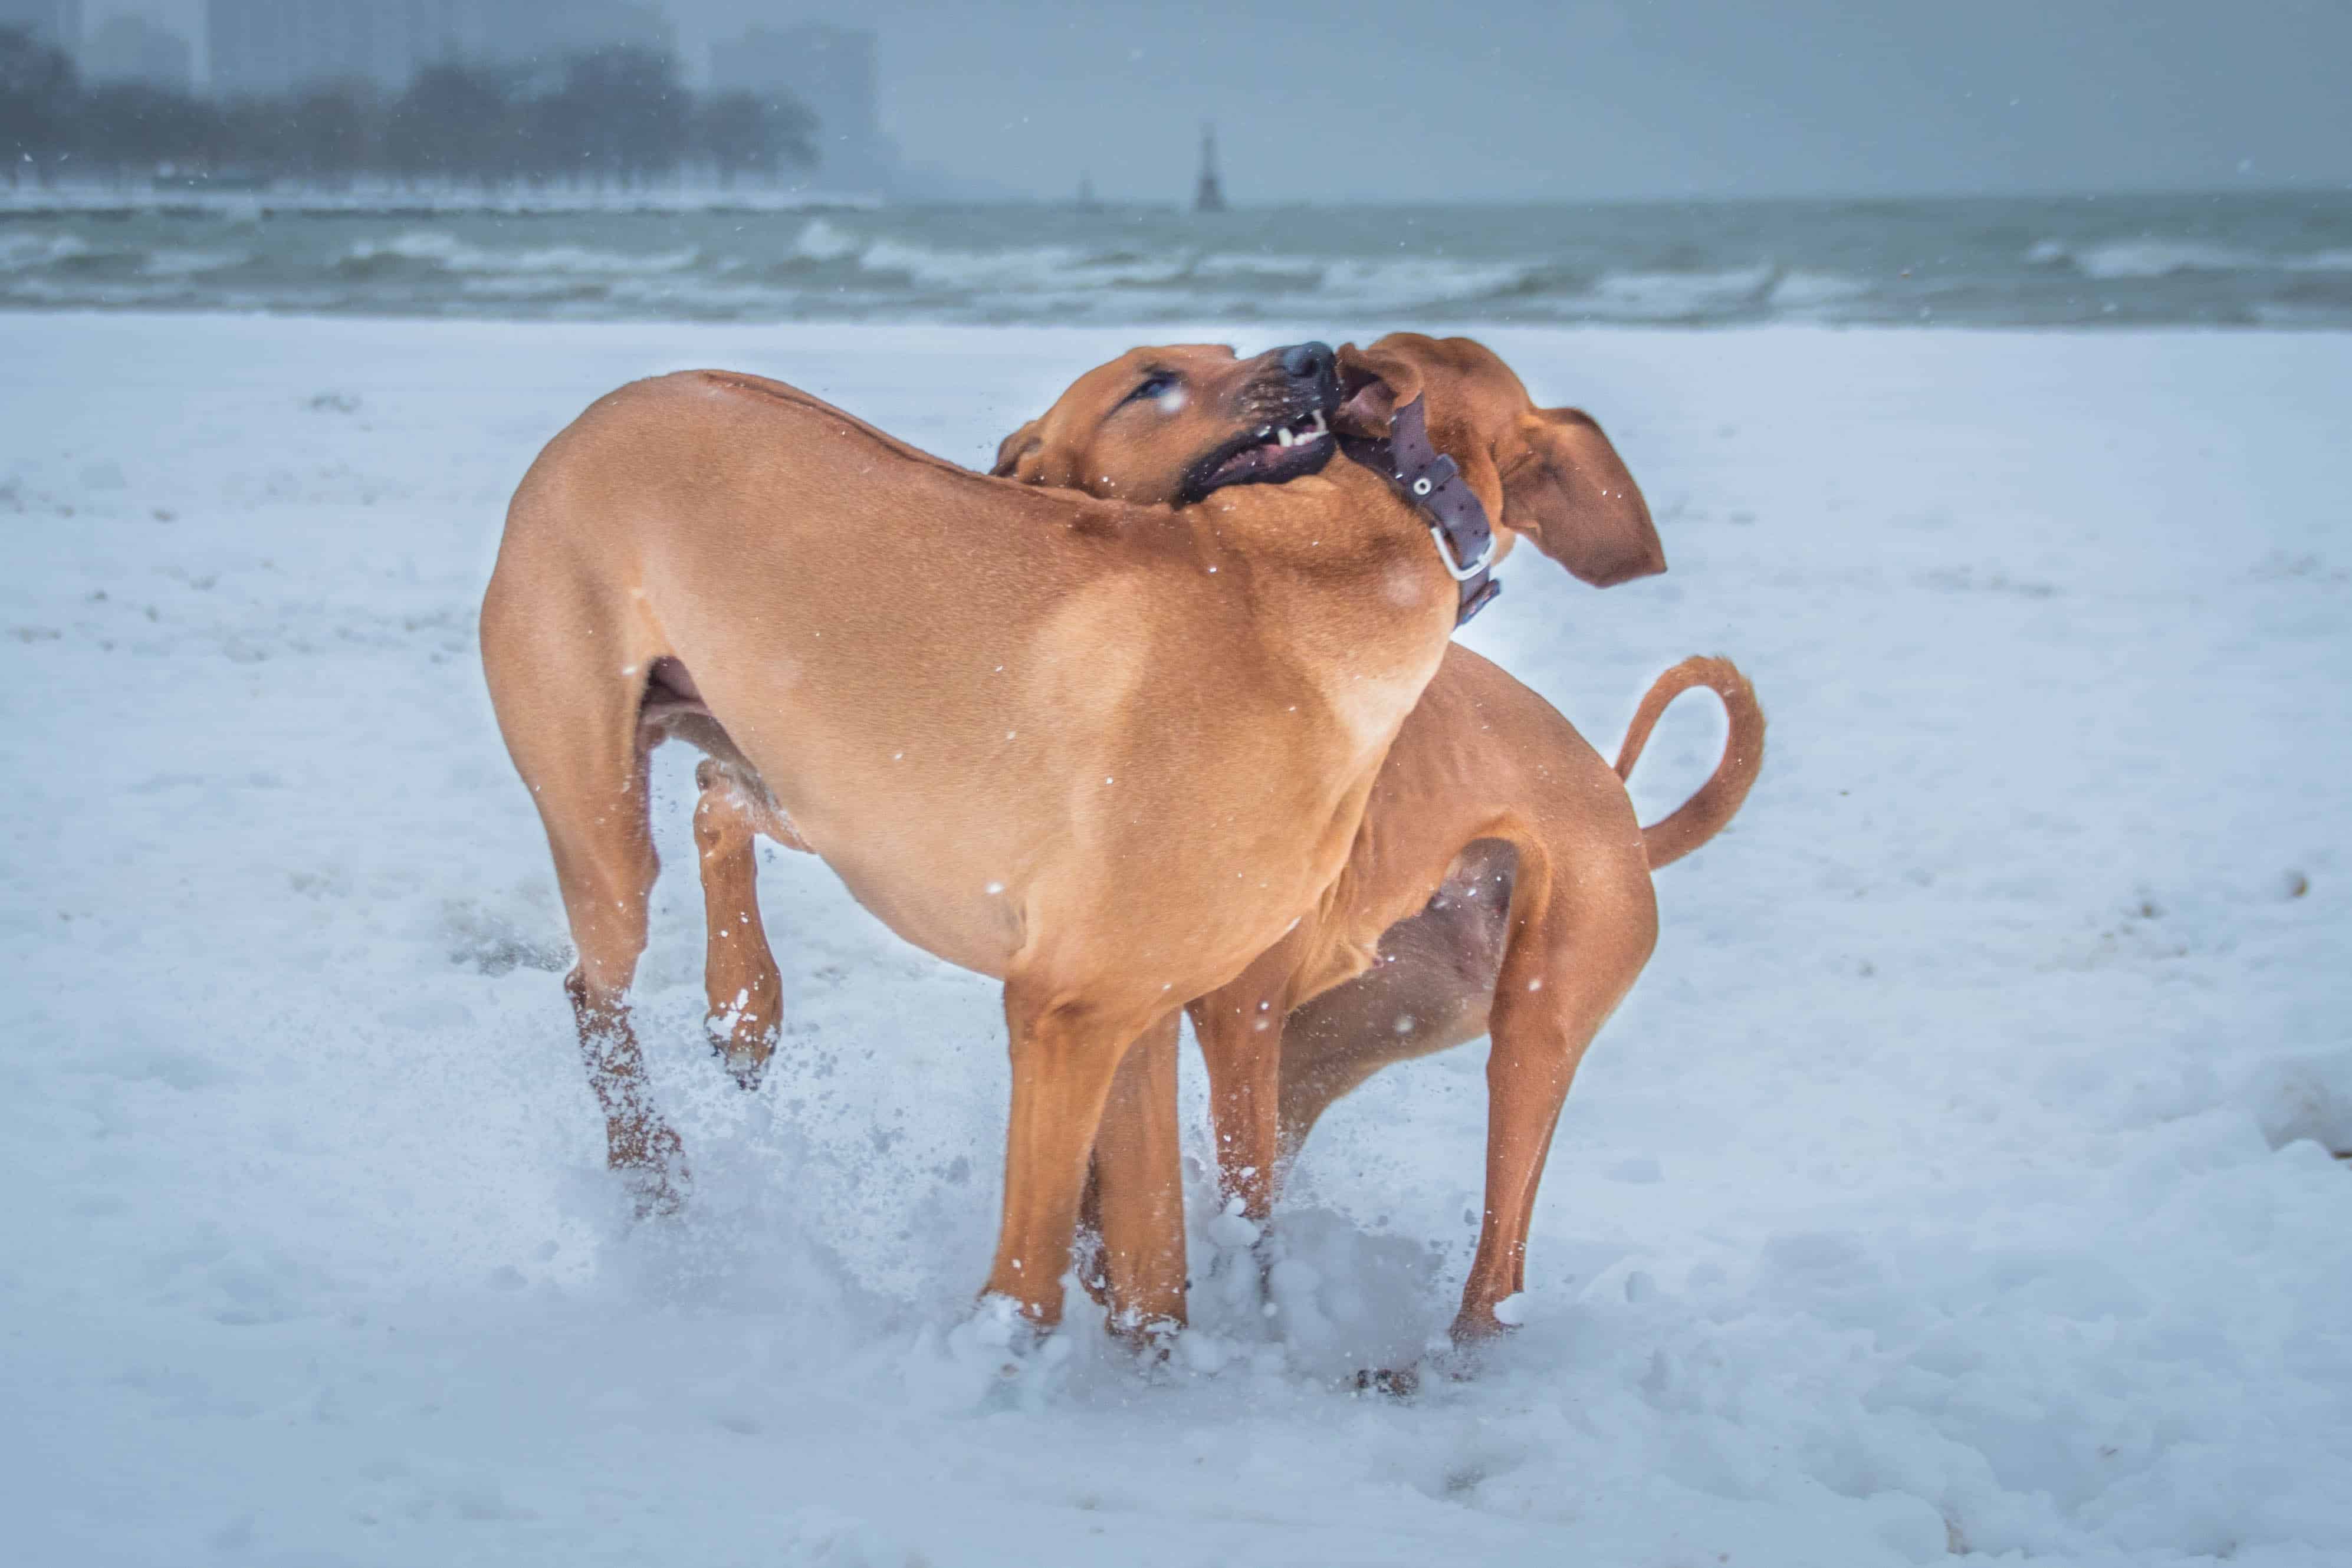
[0, 198, 2352, 334]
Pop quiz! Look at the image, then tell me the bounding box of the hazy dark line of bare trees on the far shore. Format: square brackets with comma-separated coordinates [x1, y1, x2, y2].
[0, 28, 816, 190]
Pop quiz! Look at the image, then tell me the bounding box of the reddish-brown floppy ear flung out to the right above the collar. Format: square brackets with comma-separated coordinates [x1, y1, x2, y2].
[1496, 409, 1666, 588]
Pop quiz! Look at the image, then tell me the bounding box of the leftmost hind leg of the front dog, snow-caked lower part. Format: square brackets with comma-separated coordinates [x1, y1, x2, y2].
[482, 571, 685, 1213]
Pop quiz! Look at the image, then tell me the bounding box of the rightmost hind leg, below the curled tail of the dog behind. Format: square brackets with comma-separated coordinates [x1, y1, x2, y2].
[1454, 832, 1658, 1342]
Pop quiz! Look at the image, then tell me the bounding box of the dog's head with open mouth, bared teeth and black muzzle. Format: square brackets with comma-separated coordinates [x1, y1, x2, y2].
[993, 343, 1338, 505]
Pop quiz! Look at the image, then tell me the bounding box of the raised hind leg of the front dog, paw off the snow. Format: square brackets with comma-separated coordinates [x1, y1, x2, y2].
[694, 757, 783, 1089]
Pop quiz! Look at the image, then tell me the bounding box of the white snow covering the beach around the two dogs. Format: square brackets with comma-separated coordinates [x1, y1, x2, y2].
[0, 315, 2352, 1568]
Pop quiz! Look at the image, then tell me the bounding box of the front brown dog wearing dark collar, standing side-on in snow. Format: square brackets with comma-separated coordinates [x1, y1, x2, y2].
[482, 338, 1658, 1326]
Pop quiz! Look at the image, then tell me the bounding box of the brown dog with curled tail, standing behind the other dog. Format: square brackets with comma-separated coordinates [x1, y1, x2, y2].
[978, 336, 1764, 1340]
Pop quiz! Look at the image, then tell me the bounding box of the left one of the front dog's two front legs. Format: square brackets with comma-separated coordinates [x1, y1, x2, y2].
[988, 975, 1152, 1328]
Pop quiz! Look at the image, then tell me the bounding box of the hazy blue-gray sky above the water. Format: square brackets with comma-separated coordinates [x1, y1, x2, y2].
[87, 0, 2352, 202]
